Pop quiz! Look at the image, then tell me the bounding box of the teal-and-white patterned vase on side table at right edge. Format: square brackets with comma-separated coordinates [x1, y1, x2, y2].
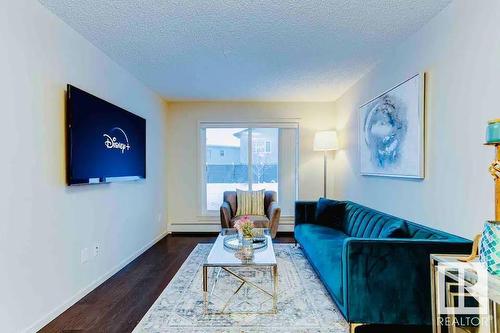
[479, 221, 500, 275]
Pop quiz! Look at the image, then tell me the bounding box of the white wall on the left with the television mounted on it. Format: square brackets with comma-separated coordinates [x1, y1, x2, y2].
[0, 0, 166, 332]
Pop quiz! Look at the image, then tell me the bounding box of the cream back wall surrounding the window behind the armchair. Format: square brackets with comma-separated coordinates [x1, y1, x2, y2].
[167, 102, 334, 231]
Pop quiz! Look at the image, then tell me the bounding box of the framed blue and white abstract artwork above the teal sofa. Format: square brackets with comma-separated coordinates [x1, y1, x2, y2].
[359, 73, 425, 178]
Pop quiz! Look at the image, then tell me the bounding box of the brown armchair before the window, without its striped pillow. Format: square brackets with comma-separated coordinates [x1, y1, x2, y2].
[220, 191, 281, 238]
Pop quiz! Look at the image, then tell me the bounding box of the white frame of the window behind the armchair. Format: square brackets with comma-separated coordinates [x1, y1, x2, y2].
[197, 119, 300, 217]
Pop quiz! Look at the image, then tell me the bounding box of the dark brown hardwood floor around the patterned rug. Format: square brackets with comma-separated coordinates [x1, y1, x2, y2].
[40, 234, 427, 333]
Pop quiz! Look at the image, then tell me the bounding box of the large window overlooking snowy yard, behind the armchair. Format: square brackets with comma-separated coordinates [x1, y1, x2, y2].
[200, 123, 298, 216]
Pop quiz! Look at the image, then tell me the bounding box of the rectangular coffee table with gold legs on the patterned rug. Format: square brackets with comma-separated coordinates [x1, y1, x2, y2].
[203, 229, 278, 315]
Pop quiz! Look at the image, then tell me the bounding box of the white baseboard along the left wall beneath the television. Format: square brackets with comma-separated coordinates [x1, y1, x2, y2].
[24, 230, 168, 332]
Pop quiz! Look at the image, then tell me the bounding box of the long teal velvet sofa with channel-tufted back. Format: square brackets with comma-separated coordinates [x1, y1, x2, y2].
[294, 199, 472, 327]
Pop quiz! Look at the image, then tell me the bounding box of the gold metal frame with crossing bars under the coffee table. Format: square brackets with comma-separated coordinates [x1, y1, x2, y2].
[203, 264, 278, 315]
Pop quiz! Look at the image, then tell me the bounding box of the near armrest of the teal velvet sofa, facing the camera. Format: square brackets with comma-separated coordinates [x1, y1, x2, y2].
[342, 238, 472, 325]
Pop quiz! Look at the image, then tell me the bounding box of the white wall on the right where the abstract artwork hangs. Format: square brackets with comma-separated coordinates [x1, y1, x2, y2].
[335, 0, 500, 238]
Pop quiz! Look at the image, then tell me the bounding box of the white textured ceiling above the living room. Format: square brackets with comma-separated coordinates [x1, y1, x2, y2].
[40, 0, 451, 101]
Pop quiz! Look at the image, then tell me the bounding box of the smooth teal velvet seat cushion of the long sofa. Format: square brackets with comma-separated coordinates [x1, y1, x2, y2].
[295, 224, 347, 305]
